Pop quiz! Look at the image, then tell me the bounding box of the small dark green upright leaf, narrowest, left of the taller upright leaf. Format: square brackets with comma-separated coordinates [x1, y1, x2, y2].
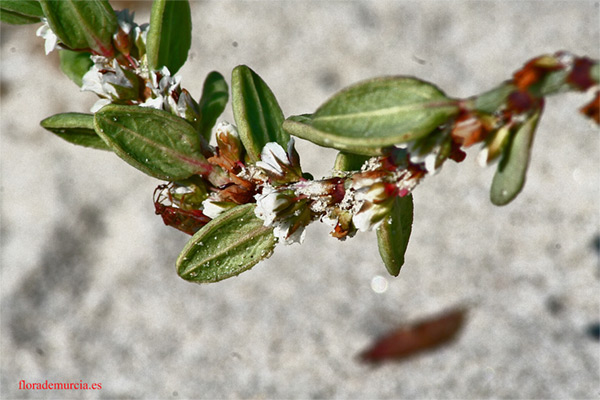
[198, 71, 229, 141]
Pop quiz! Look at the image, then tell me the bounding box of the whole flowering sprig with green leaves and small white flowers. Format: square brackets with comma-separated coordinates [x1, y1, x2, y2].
[0, 0, 600, 283]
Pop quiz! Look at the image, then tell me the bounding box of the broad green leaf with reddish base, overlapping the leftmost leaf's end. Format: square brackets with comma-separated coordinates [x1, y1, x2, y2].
[94, 105, 213, 181]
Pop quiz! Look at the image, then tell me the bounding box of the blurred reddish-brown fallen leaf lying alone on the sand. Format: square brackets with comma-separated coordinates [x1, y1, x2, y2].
[360, 309, 466, 363]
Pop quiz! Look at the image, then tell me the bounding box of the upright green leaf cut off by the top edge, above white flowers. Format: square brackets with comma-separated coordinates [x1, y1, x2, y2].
[146, 0, 192, 75]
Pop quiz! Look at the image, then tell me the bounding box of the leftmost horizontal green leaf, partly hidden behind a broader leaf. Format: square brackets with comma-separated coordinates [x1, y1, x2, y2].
[40, 113, 110, 150]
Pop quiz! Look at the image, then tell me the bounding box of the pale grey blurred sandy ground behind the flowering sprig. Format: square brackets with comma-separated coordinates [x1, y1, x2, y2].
[0, 1, 600, 399]
